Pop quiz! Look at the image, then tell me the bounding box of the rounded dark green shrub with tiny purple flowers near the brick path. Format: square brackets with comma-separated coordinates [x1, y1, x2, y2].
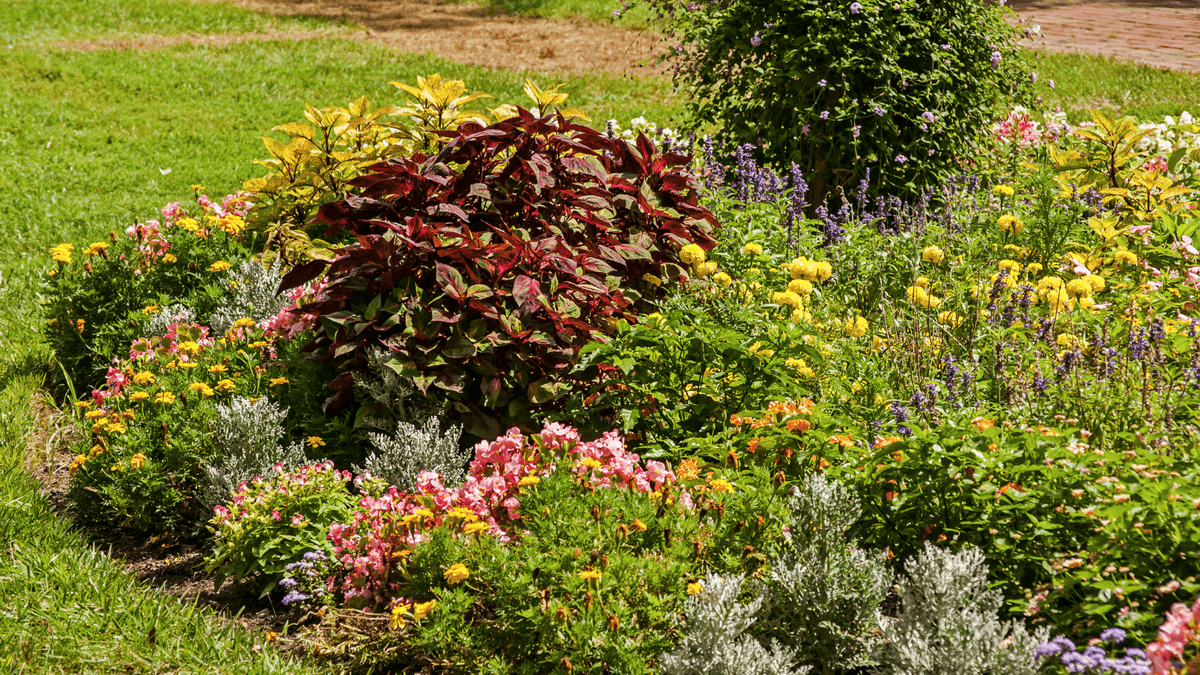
[650, 0, 1030, 196]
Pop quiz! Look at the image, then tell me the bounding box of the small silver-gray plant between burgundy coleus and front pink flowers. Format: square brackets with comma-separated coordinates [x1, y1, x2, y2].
[354, 417, 470, 490]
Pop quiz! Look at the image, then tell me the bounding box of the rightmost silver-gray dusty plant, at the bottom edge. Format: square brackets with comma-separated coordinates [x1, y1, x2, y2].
[877, 542, 1049, 675]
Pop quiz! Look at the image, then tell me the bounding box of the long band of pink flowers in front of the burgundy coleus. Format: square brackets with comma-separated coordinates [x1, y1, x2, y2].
[329, 423, 690, 608]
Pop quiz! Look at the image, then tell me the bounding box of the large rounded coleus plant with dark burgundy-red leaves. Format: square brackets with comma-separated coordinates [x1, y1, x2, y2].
[281, 109, 716, 436]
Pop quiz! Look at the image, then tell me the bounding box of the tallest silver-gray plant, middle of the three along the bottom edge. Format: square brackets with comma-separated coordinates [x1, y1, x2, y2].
[760, 473, 893, 670]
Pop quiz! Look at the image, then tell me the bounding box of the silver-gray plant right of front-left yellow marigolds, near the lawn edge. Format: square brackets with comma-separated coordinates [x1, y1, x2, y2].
[200, 396, 306, 509]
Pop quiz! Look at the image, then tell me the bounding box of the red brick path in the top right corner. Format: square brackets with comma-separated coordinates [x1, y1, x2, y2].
[1008, 0, 1200, 72]
